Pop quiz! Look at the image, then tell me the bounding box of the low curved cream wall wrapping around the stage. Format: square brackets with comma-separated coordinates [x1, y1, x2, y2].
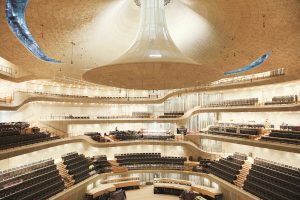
[50, 170, 259, 200]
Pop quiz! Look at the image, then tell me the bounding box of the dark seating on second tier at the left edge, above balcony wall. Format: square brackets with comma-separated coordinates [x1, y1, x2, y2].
[0, 122, 59, 150]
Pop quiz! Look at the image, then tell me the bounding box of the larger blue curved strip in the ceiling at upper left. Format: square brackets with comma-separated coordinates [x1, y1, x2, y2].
[5, 0, 61, 63]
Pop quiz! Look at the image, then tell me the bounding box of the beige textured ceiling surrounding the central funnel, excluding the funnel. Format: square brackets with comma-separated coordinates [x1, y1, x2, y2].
[0, 0, 300, 89]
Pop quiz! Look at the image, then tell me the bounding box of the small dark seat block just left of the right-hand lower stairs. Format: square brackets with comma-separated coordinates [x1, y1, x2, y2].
[209, 153, 247, 183]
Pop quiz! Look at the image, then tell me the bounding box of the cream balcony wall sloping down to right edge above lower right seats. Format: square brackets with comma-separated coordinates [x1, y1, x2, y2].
[186, 134, 300, 168]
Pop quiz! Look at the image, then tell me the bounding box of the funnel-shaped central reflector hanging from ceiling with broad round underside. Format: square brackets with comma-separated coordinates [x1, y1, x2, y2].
[83, 0, 222, 90]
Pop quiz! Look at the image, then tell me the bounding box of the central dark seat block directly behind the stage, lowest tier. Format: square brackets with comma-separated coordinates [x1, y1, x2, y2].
[115, 153, 187, 169]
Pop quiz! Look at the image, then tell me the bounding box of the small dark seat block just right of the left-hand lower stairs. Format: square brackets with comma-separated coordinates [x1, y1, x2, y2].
[62, 152, 95, 183]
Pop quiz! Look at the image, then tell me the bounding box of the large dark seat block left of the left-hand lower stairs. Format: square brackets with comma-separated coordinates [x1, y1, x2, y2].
[0, 159, 64, 200]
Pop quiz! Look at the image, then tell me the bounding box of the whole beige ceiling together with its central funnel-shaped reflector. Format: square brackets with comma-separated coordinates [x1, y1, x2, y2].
[0, 0, 300, 90]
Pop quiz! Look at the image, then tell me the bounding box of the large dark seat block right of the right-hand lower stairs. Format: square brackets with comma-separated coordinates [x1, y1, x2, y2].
[243, 158, 300, 200]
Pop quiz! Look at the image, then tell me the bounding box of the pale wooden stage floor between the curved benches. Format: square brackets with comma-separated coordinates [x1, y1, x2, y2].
[126, 185, 179, 200]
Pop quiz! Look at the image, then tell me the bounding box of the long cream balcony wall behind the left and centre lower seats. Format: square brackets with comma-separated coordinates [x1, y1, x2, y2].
[0, 136, 217, 170]
